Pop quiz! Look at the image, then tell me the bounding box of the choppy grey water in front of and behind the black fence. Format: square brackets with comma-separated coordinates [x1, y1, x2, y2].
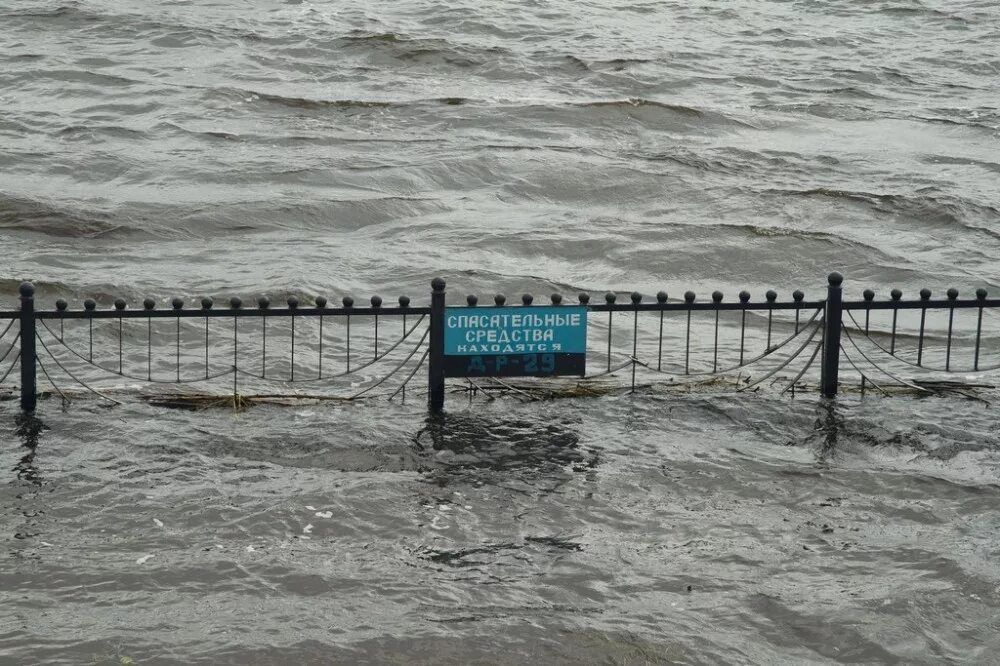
[0, 0, 1000, 664]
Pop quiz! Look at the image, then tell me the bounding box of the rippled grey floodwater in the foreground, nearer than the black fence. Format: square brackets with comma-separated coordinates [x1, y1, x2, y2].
[0, 396, 1000, 664]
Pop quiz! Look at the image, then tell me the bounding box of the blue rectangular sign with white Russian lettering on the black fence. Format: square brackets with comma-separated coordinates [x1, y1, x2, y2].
[444, 306, 587, 377]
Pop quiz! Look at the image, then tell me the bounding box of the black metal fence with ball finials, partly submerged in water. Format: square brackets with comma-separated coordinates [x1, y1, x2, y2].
[0, 273, 1000, 412]
